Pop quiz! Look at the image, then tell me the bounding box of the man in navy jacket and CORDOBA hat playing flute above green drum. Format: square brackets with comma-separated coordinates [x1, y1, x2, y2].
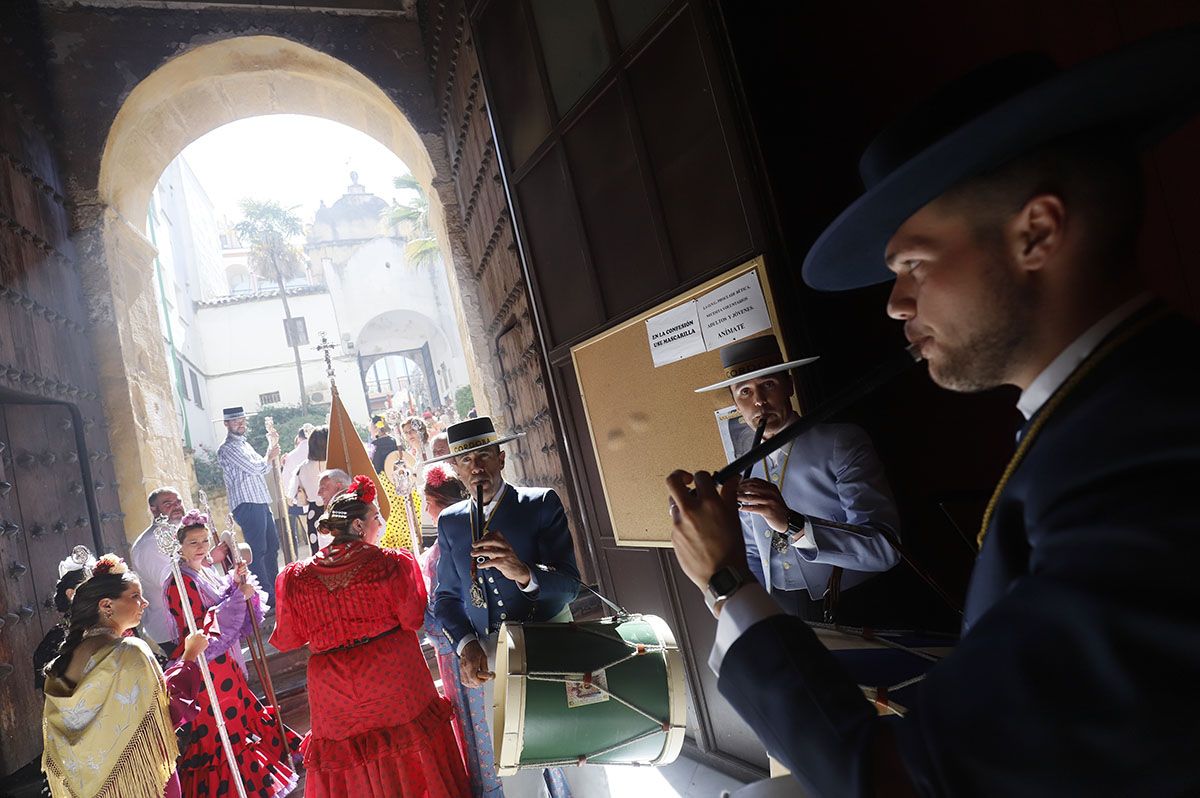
[430, 415, 580, 794]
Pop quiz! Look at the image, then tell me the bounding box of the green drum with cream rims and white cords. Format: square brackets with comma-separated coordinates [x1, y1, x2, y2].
[493, 614, 688, 775]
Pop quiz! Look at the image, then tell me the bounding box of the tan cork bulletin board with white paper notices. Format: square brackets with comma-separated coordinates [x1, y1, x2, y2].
[571, 257, 790, 547]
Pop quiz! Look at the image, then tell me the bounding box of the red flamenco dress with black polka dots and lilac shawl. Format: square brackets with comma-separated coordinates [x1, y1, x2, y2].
[164, 568, 300, 798]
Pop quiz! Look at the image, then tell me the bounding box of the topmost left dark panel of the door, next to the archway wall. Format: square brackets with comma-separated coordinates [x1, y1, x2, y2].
[476, 1, 551, 170]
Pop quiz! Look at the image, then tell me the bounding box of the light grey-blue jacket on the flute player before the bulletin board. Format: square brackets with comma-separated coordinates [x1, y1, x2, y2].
[740, 424, 900, 599]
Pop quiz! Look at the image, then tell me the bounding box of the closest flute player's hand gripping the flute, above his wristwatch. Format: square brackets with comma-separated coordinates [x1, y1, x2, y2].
[667, 470, 746, 590]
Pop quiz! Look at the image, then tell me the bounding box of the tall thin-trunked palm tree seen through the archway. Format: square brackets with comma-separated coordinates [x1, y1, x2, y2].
[234, 198, 308, 412]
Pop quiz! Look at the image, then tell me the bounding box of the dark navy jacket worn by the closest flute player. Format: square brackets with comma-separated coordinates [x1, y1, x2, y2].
[719, 307, 1200, 798]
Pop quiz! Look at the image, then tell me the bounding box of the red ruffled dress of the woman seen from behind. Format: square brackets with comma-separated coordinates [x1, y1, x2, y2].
[271, 541, 470, 798]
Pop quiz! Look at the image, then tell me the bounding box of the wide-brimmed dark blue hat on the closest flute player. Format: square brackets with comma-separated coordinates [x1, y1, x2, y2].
[803, 25, 1200, 290]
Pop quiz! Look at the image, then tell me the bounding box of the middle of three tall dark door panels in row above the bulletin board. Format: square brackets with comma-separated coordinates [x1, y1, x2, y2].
[563, 82, 676, 317]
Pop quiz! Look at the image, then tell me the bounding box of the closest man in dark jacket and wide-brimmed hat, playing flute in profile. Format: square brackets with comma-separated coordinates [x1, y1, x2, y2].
[668, 29, 1200, 797]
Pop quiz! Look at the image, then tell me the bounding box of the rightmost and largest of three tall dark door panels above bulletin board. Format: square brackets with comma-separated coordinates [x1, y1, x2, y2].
[628, 6, 752, 280]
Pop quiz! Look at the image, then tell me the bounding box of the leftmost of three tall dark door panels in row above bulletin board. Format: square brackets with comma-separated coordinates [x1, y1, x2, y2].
[517, 148, 605, 347]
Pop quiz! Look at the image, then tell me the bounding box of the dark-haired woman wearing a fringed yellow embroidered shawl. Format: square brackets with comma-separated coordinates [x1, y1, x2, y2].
[42, 554, 208, 798]
